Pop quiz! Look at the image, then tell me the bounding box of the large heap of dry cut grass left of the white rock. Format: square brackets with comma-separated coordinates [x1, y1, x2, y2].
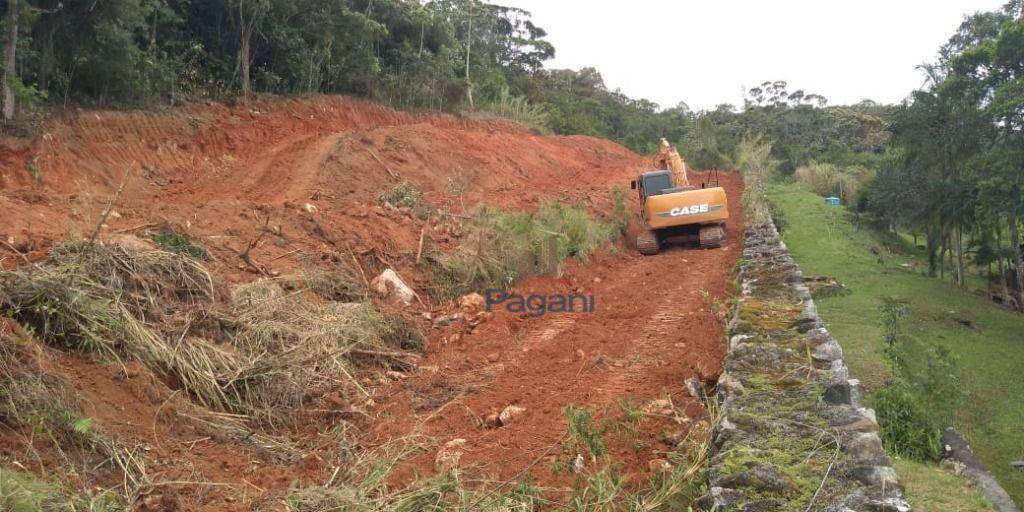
[0, 243, 415, 424]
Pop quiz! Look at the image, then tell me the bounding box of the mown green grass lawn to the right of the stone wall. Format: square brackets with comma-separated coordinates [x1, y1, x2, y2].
[769, 184, 1024, 510]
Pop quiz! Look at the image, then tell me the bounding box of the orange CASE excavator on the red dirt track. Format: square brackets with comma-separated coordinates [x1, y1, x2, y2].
[630, 138, 729, 255]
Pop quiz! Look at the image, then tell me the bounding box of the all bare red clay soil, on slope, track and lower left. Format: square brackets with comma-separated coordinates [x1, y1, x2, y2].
[0, 96, 742, 511]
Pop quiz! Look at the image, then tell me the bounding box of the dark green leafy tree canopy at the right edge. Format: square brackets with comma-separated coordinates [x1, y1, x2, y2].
[866, 0, 1024, 306]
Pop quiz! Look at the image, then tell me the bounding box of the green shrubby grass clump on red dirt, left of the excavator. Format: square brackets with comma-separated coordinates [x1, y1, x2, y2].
[433, 203, 621, 297]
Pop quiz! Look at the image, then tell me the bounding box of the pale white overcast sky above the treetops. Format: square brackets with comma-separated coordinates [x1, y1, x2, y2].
[496, 0, 1006, 110]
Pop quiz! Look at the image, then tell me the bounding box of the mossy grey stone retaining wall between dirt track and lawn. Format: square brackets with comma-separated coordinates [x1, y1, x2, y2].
[697, 218, 910, 512]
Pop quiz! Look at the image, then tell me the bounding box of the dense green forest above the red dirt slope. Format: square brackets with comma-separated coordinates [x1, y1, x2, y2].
[3, 0, 688, 150]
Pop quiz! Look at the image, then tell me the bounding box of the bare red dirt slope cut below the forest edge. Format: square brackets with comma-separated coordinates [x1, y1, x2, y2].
[0, 97, 640, 280]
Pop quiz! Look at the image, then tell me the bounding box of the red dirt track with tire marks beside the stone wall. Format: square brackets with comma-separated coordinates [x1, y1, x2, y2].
[369, 174, 742, 487]
